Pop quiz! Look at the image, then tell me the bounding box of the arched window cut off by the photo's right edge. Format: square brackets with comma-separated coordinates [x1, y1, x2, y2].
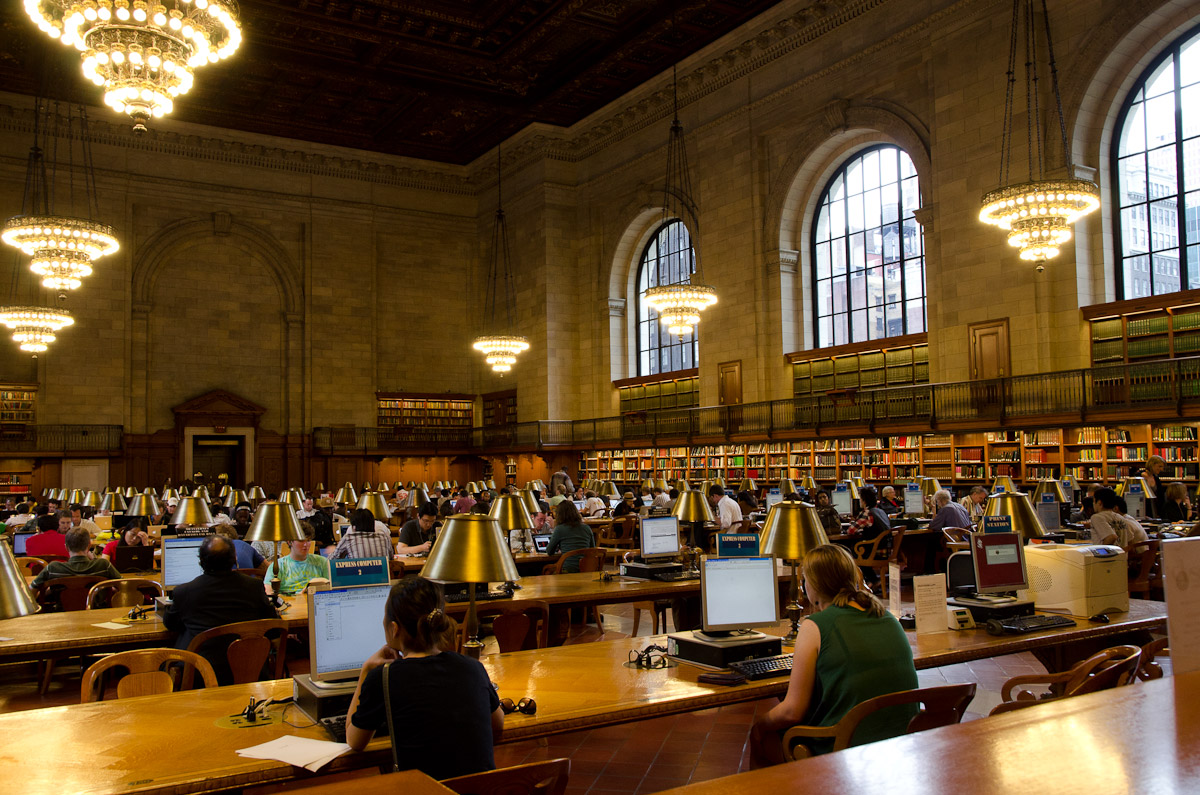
[1112, 30, 1200, 298]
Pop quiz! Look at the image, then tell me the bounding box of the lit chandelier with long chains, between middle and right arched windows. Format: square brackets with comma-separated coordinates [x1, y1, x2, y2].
[979, 0, 1100, 271]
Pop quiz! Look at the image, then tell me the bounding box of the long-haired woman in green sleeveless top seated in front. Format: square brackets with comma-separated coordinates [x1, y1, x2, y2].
[750, 544, 917, 766]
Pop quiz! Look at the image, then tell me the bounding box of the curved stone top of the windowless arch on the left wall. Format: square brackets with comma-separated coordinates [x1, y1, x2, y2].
[132, 213, 304, 315]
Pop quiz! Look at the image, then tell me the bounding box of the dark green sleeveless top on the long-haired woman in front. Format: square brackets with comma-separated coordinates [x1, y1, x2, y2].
[804, 605, 917, 753]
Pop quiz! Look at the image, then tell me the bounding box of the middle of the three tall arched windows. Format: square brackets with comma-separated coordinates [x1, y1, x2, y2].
[812, 145, 925, 348]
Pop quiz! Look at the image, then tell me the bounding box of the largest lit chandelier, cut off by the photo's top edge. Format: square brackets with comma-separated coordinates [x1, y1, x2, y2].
[24, 0, 241, 132]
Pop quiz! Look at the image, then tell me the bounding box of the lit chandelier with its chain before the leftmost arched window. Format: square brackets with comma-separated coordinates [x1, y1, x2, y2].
[642, 66, 716, 336]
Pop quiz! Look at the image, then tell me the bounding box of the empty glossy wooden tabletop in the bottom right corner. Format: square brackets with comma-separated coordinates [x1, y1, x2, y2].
[666, 673, 1200, 795]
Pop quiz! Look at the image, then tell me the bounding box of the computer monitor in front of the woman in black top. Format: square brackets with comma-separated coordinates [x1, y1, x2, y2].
[308, 585, 391, 686]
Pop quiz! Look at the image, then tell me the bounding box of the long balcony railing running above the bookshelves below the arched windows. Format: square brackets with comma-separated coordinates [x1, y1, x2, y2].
[313, 357, 1200, 453]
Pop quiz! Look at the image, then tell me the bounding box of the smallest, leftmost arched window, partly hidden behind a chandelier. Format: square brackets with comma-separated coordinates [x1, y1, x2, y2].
[637, 221, 698, 376]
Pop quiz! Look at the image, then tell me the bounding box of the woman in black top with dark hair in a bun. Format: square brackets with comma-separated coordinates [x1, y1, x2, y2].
[346, 576, 504, 779]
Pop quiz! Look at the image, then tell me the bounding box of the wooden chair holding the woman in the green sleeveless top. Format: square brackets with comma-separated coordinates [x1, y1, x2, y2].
[784, 682, 976, 760]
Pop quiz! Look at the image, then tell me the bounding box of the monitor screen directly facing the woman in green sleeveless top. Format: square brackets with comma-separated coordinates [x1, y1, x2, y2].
[700, 557, 779, 632]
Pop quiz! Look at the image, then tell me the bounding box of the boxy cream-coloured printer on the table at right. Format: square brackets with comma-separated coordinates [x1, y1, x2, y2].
[1025, 544, 1129, 616]
